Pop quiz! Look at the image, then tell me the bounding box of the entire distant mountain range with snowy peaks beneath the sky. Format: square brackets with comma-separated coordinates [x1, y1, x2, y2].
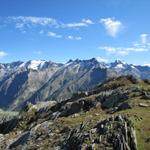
[0, 58, 150, 109]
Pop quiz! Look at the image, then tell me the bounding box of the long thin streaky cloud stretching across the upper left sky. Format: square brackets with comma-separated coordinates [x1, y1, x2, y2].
[5, 16, 94, 30]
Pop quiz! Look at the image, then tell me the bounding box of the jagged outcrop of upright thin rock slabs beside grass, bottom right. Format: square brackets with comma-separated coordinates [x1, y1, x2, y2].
[96, 115, 137, 150]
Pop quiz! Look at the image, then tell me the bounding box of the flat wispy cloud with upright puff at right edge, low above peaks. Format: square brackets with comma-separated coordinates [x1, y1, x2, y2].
[99, 34, 150, 55]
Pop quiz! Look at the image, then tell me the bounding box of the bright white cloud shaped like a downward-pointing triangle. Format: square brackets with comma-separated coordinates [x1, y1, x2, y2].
[100, 18, 123, 37]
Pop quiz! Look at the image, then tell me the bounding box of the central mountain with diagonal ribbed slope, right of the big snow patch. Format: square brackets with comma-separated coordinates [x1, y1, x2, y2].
[25, 60, 107, 103]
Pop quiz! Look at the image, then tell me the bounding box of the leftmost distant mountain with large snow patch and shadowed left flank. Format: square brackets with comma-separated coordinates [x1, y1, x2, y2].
[0, 61, 61, 109]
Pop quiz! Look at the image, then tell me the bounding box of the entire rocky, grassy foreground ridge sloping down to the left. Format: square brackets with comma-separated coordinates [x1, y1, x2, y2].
[0, 76, 150, 150]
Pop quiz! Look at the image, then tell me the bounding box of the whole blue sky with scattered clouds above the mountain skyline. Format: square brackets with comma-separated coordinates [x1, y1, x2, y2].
[0, 0, 150, 65]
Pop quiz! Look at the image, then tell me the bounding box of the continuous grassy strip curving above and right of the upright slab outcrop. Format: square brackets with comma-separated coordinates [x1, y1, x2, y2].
[52, 102, 150, 150]
